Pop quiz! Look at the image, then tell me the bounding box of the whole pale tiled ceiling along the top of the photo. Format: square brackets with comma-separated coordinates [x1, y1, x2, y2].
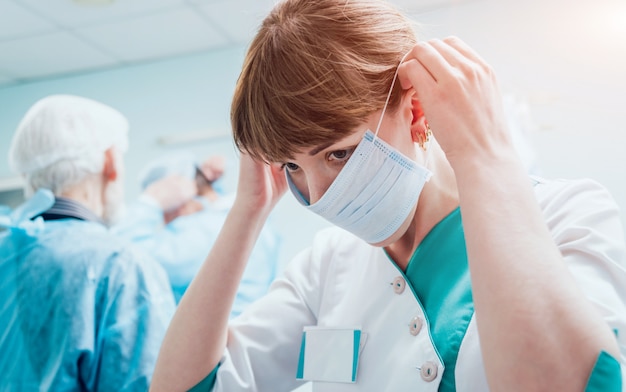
[0, 0, 481, 85]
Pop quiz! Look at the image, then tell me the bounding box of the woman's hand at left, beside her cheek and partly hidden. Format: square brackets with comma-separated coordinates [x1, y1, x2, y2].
[236, 152, 287, 214]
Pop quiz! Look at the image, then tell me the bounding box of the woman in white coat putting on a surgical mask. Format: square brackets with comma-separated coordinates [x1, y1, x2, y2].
[153, 0, 626, 391]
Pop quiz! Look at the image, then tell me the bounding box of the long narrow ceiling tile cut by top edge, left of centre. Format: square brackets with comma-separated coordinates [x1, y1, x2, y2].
[21, 0, 184, 27]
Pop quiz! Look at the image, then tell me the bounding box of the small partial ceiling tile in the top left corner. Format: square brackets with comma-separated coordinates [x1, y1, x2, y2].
[0, 0, 55, 40]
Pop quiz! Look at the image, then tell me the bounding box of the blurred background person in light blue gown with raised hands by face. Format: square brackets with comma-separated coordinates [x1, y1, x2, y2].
[114, 152, 280, 318]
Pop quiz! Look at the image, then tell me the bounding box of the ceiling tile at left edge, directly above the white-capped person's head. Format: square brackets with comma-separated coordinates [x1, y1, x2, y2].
[0, 33, 115, 79]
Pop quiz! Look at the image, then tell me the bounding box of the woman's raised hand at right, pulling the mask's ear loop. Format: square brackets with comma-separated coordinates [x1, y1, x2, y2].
[398, 37, 513, 168]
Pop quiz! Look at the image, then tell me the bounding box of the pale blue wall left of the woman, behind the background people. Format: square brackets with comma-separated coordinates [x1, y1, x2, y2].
[0, 47, 328, 265]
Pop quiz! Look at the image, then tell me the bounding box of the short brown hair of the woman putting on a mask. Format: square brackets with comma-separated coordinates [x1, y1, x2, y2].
[231, 0, 417, 162]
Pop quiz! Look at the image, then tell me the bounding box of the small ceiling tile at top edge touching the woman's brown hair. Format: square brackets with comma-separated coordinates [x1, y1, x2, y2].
[195, 0, 276, 43]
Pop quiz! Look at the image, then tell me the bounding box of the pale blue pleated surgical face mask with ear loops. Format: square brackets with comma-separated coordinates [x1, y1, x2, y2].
[285, 55, 432, 244]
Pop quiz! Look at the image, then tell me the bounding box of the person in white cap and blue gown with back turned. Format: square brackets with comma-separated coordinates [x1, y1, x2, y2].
[0, 95, 175, 391]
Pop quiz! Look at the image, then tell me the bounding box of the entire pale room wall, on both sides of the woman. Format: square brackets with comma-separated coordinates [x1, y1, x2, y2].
[0, 0, 626, 263]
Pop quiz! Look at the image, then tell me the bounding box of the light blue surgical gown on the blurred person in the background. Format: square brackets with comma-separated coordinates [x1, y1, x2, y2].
[114, 195, 280, 318]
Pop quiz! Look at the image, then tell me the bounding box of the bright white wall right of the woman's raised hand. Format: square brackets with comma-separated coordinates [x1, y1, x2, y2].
[415, 0, 626, 234]
